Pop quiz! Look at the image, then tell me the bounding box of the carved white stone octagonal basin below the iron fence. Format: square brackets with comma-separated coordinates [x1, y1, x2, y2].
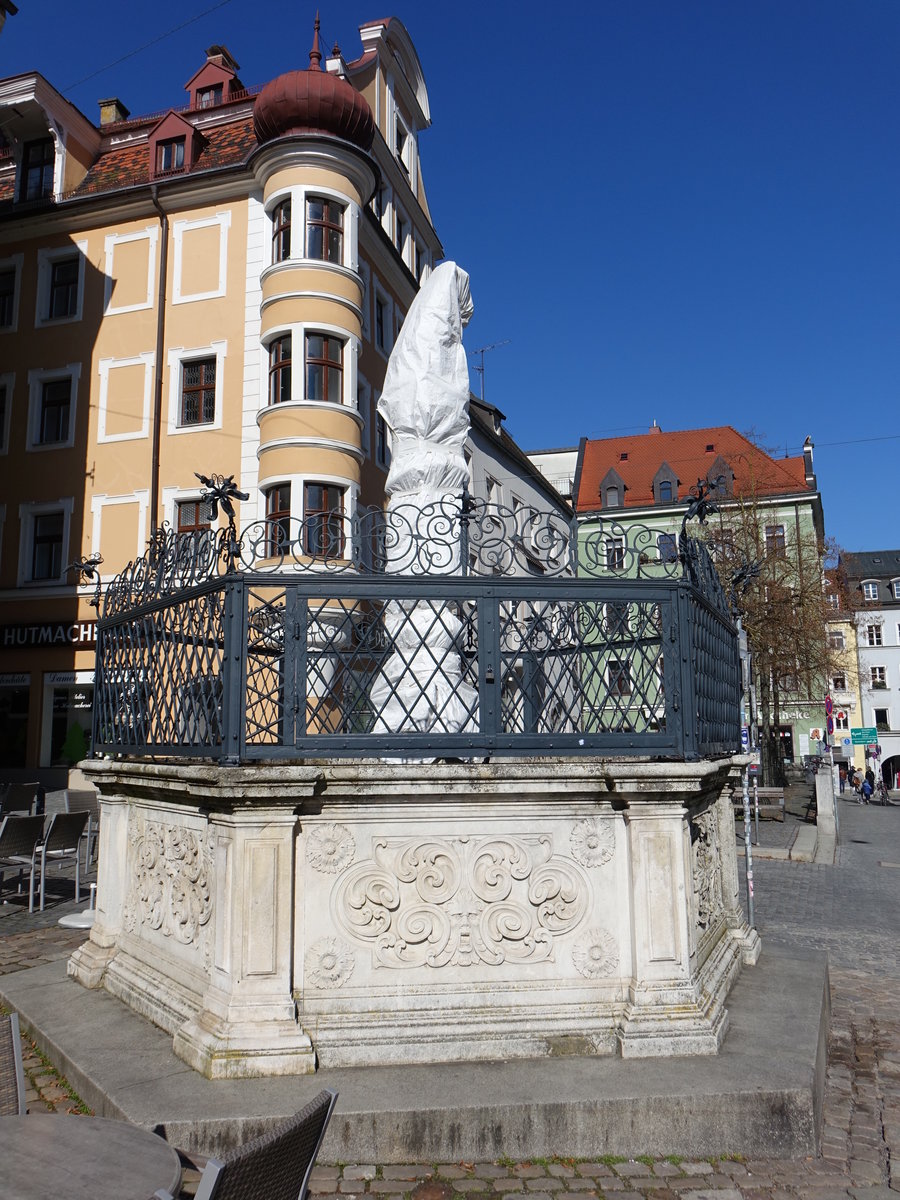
[70, 758, 758, 1078]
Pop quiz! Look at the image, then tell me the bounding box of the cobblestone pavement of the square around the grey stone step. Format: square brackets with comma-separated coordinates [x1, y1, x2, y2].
[0, 788, 900, 1200]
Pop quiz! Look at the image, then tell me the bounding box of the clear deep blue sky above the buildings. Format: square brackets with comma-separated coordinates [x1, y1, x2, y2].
[0, 0, 900, 550]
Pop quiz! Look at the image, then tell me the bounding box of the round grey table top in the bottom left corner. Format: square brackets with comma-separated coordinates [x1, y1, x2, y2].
[0, 1112, 181, 1200]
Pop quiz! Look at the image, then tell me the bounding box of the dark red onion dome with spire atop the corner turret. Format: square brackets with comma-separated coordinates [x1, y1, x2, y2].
[253, 17, 374, 150]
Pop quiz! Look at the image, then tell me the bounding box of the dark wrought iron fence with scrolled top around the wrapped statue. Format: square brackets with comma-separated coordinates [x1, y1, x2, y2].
[94, 498, 740, 762]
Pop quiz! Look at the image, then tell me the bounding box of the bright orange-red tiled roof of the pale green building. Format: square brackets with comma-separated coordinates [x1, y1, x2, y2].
[575, 425, 810, 512]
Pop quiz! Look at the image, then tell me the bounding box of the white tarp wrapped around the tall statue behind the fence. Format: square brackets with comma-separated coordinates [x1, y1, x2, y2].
[371, 263, 478, 733]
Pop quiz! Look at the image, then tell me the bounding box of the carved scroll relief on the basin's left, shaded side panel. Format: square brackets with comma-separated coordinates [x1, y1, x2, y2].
[124, 812, 212, 966]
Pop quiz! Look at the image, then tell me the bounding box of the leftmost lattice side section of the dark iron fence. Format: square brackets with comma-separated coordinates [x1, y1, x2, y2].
[94, 588, 224, 755]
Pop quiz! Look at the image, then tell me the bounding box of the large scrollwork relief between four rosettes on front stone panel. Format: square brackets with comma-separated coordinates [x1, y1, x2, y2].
[334, 835, 590, 967]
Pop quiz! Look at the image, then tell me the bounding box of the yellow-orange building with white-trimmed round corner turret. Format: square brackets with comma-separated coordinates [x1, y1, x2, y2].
[0, 19, 442, 784]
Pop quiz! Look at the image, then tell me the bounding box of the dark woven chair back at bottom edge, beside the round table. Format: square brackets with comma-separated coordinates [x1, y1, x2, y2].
[155, 1088, 337, 1200]
